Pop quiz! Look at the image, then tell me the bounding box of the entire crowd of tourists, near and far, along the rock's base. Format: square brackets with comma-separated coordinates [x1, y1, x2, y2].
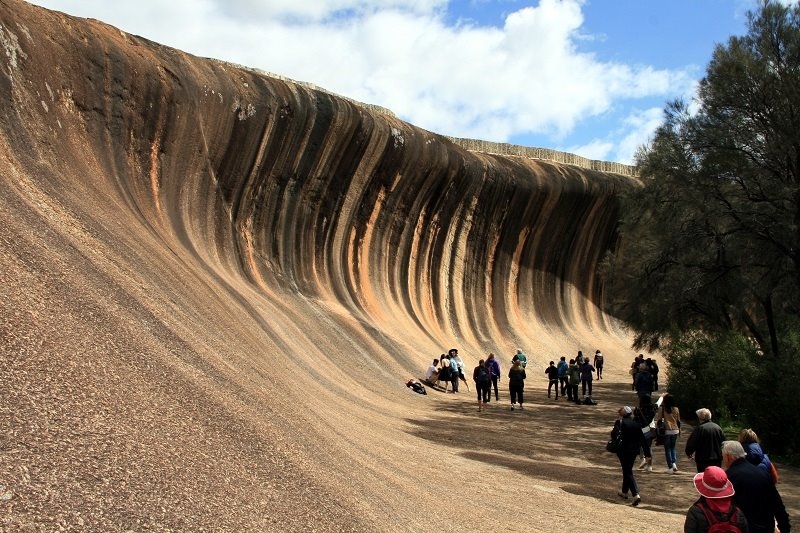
[416, 348, 791, 533]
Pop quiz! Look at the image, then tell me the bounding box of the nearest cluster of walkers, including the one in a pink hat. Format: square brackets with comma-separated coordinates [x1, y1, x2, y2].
[611, 400, 790, 533]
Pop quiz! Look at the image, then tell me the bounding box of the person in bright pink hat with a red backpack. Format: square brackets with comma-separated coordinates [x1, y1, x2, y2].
[683, 466, 748, 533]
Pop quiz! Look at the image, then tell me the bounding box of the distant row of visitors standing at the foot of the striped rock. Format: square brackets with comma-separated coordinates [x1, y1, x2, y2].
[424, 348, 603, 411]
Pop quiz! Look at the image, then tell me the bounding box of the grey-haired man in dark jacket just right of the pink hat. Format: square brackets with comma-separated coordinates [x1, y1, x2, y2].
[722, 440, 790, 533]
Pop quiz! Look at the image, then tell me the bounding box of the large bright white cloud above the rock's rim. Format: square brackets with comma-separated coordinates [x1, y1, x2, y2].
[28, 0, 691, 162]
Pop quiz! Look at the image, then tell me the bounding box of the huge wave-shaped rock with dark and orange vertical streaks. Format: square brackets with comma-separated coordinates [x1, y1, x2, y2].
[0, 0, 700, 531]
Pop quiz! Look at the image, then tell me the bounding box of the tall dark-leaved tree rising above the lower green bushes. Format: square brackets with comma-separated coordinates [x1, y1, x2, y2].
[607, 0, 800, 357]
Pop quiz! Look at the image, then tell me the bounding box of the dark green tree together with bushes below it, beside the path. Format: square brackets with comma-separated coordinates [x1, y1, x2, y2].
[601, 0, 800, 460]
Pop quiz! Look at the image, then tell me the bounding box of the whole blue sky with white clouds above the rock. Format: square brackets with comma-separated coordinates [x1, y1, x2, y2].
[32, 0, 788, 163]
